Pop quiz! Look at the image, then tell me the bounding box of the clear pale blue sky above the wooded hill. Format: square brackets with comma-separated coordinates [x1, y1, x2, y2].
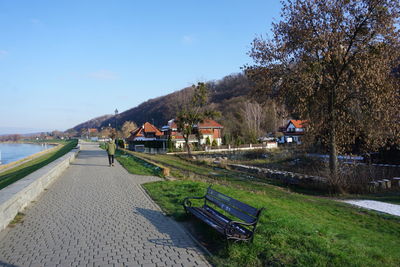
[0, 0, 281, 134]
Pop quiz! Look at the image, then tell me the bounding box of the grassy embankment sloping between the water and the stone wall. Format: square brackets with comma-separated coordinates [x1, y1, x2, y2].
[0, 140, 78, 189]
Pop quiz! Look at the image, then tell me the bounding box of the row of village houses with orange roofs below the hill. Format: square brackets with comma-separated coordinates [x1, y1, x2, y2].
[81, 119, 305, 153]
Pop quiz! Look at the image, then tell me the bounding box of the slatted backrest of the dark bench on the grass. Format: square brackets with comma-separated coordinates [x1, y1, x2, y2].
[205, 187, 260, 223]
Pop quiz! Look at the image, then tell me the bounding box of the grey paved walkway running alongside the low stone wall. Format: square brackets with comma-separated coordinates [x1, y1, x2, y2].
[0, 145, 209, 267]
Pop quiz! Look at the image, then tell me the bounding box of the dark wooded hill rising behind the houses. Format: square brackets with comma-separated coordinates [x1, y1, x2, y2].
[69, 73, 282, 141]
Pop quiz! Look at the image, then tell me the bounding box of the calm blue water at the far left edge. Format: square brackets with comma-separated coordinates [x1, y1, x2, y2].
[0, 143, 53, 164]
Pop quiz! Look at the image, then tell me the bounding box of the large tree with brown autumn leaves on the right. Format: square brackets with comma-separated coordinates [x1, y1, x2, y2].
[246, 0, 400, 193]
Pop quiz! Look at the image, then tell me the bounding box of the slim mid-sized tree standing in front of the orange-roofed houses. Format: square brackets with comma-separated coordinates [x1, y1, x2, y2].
[176, 82, 216, 156]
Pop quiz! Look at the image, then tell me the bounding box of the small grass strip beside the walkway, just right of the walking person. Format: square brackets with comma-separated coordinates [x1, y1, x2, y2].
[116, 151, 162, 177]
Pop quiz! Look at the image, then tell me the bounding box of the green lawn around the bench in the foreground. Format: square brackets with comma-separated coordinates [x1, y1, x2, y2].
[144, 181, 400, 266]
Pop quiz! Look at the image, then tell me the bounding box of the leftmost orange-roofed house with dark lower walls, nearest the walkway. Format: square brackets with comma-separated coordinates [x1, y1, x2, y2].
[126, 122, 166, 153]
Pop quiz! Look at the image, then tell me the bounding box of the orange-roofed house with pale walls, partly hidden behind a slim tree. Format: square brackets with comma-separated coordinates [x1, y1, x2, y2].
[161, 119, 224, 148]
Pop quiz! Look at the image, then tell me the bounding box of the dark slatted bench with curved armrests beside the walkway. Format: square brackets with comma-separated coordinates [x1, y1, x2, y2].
[183, 186, 264, 241]
